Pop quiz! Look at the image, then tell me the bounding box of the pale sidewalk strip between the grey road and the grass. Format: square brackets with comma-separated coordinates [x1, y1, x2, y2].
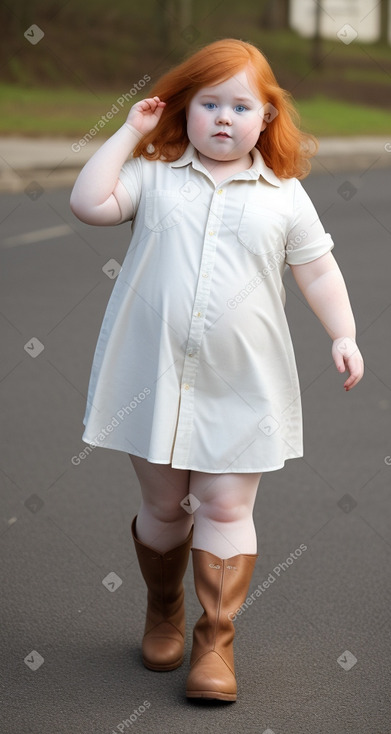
[0, 134, 391, 192]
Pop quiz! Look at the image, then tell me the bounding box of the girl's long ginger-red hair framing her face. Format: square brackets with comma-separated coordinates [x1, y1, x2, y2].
[133, 38, 317, 178]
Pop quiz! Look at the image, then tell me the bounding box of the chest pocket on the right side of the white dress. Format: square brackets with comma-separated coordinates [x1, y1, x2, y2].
[238, 204, 286, 255]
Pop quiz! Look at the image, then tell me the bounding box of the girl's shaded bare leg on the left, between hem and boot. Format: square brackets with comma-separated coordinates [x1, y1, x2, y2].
[129, 454, 193, 553]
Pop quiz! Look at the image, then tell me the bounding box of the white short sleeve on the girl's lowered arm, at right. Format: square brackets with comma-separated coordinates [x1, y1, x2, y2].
[285, 179, 334, 265]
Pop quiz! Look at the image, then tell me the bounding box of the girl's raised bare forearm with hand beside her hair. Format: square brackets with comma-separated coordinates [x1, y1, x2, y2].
[70, 97, 165, 225]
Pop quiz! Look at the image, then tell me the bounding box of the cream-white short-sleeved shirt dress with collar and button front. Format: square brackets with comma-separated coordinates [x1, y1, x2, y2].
[83, 143, 334, 473]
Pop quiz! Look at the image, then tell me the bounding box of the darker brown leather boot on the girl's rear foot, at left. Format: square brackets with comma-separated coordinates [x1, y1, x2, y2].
[132, 516, 193, 670]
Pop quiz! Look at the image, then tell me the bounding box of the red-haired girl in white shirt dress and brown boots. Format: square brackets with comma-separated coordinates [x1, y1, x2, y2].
[71, 39, 363, 701]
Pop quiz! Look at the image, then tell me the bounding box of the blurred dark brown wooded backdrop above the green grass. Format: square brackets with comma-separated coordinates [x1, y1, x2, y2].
[0, 0, 391, 98]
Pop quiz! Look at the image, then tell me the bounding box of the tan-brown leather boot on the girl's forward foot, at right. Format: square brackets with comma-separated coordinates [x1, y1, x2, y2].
[186, 548, 258, 701]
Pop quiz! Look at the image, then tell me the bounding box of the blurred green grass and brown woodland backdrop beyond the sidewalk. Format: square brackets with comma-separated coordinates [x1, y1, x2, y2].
[0, 0, 391, 138]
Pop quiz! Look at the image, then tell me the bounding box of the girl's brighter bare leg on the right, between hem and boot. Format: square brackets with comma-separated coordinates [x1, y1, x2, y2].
[189, 471, 262, 559]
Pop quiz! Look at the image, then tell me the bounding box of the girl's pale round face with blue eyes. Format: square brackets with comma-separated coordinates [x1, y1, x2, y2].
[187, 69, 266, 162]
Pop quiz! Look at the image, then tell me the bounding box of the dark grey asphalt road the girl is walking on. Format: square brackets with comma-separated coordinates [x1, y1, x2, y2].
[0, 170, 391, 734]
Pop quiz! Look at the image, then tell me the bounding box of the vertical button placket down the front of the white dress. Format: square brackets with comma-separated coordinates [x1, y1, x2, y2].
[172, 187, 225, 463]
